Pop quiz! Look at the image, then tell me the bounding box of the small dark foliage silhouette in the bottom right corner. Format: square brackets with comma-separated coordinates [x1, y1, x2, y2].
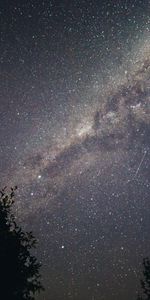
[137, 257, 150, 300]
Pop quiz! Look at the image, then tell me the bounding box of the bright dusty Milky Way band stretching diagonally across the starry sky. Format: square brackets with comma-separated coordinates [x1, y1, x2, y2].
[11, 40, 150, 214]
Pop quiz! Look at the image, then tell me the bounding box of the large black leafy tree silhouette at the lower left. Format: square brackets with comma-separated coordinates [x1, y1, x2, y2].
[0, 187, 43, 300]
